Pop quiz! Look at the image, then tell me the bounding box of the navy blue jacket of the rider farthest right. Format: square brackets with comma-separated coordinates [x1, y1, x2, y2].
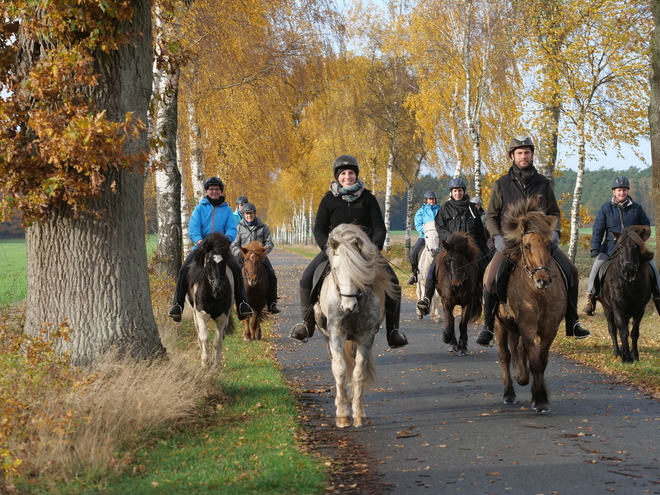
[591, 196, 651, 256]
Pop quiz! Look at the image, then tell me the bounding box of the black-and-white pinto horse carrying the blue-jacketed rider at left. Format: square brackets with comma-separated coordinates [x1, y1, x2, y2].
[186, 232, 234, 368]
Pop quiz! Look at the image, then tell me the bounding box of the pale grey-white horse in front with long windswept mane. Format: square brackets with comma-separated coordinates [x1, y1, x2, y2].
[314, 224, 397, 428]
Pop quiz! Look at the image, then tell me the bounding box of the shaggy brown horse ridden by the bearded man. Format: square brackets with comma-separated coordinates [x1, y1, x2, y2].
[495, 198, 567, 413]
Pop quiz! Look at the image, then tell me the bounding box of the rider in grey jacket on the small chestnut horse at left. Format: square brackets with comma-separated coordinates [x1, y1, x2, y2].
[231, 203, 280, 315]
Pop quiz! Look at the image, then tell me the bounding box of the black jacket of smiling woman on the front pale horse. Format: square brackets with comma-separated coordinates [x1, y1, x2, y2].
[314, 189, 386, 249]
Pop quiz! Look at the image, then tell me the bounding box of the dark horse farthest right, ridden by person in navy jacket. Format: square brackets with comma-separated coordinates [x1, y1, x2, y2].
[598, 225, 653, 363]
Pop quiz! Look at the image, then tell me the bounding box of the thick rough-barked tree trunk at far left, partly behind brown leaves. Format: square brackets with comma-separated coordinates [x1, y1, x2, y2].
[18, 0, 165, 365]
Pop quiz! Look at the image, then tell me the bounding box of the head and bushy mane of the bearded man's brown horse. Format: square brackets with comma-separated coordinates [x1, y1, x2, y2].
[502, 198, 559, 289]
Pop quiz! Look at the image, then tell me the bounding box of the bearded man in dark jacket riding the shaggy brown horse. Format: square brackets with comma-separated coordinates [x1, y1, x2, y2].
[477, 136, 590, 345]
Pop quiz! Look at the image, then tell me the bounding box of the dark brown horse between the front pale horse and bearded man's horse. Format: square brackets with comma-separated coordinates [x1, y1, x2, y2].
[435, 232, 483, 356]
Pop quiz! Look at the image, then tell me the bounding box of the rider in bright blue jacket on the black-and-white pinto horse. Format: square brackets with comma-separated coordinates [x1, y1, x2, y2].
[168, 177, 252, 322]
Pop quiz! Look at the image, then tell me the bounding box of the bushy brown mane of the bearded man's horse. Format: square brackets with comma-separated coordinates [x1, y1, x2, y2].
[502, 196, 559, 259]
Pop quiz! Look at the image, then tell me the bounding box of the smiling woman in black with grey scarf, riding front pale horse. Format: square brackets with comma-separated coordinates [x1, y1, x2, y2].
[290, 155, 408, 349]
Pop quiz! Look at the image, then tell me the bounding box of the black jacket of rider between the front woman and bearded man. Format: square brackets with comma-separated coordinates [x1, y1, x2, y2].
[435, 194, 489, 254]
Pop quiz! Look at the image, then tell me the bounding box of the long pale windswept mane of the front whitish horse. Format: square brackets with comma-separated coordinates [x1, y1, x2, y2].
[326, 223, 398, 301]
